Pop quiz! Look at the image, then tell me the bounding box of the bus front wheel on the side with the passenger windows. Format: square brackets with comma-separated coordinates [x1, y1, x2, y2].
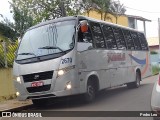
[85, 81, 96, 103]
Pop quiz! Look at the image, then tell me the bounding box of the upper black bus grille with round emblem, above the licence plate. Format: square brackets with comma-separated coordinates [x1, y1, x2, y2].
[23, 71, 53, 82]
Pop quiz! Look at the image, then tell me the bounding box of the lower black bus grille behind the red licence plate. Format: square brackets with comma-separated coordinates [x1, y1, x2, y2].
[27, 85, 51, 93]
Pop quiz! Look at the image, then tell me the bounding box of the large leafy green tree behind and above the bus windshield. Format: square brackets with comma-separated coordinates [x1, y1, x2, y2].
[10, 0, 79, 36]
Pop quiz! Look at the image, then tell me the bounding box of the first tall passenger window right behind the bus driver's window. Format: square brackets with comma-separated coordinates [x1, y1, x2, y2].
[90, 22, 105, 48]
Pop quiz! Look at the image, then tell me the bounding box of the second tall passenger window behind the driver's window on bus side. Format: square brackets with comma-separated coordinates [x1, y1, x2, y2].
[102, 25, 117, 50]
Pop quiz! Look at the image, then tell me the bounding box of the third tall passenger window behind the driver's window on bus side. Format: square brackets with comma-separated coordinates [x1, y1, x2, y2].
[113, 27, 126, 49]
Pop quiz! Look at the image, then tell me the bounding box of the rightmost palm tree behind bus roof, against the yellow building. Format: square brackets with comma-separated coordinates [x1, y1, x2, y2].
[110, 0, 126, 24]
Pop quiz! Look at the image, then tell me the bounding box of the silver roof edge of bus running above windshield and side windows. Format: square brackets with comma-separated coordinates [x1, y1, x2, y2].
[28, 15, 144, 33]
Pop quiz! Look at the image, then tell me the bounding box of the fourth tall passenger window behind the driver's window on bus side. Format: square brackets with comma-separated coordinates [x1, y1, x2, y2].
[123, 29, 135, 50]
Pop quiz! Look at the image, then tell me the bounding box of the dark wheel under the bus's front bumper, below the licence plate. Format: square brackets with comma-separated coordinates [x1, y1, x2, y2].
[32, 99, 48, 107]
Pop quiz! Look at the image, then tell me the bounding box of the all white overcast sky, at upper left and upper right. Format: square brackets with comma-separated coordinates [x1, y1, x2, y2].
[0, 0, 160, 37]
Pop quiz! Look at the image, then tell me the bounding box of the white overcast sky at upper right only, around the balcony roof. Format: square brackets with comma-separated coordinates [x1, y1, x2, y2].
[120, 0, 160, 37]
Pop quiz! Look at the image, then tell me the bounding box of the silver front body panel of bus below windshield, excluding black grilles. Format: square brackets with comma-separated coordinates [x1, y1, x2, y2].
[13, 50, 79, 100]
